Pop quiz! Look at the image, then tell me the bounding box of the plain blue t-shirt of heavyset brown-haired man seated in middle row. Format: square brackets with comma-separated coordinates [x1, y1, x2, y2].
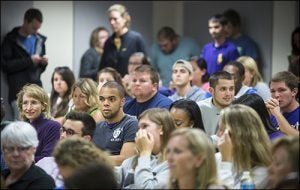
[123, 92, 173, 117]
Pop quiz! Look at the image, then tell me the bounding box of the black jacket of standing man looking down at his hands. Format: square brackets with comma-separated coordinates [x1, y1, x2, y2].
[1, 27, 47, 102]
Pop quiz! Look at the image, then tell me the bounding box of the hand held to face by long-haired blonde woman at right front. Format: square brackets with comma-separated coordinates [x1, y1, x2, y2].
[218, 129, 232, 162]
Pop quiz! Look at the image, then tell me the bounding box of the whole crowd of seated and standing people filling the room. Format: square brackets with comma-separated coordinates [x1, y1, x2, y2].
[1, 3, 300, 189]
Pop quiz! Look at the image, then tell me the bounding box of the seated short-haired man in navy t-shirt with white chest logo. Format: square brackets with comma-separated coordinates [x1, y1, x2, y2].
[93, 81, 138, 165]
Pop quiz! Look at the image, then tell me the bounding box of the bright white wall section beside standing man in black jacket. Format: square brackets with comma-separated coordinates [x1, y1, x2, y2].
[33, 1, 74, 93]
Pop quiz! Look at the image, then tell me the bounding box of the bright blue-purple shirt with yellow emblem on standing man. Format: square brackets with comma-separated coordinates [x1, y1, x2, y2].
[200, 40, 239, 75]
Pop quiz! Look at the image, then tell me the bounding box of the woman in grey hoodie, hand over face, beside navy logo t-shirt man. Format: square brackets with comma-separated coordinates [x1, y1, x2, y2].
[116, 108, 175, 189]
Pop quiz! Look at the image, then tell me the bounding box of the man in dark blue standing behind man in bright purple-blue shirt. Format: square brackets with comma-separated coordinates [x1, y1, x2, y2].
[223, 9, 258, 61]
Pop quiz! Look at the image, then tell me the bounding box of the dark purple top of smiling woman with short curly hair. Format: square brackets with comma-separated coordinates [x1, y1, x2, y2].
[30, 114, 60, 162]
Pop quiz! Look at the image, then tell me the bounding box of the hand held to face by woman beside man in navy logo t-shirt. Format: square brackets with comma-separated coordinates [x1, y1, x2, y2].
[135, 129, 154, 156]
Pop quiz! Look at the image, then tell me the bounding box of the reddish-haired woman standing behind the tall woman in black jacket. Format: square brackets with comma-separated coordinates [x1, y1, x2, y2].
[79, 27, 109, 81]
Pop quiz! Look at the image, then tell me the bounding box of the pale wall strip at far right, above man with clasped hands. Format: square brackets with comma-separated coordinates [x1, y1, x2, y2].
[272, 1, 299, 74]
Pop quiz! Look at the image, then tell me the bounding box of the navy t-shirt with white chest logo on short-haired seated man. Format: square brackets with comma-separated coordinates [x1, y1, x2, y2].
[92, 115, 138, 155]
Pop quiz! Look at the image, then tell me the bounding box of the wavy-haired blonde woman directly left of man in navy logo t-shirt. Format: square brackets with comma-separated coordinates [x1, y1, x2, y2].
[71, 78, 104, 123]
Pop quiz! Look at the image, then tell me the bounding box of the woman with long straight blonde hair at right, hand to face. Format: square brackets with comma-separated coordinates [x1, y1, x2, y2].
[216, 104, 272, 189]
